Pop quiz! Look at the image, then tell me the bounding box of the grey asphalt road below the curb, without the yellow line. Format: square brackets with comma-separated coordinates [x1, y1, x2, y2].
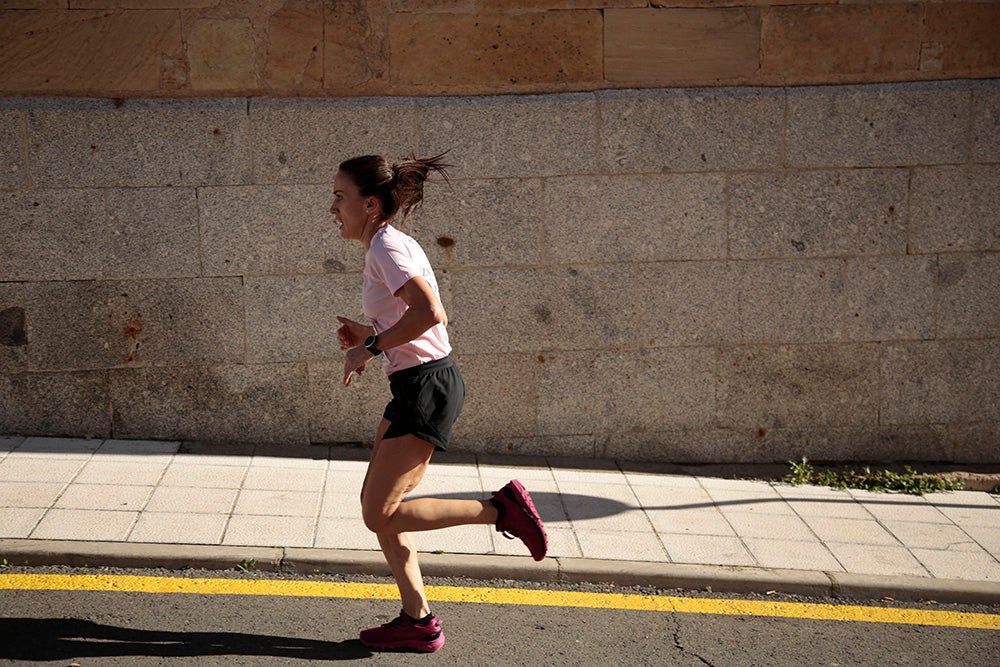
[0, 569, 1000, 667]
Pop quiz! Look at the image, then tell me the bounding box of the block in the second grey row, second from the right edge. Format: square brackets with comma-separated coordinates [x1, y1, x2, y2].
[729, 169, 908, 258]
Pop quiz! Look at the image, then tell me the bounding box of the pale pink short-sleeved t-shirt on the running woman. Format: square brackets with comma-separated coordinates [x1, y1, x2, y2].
[361, 225, 451, 375]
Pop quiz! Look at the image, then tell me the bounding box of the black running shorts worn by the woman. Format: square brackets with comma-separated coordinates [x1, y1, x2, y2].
[383, 355, 465, 452]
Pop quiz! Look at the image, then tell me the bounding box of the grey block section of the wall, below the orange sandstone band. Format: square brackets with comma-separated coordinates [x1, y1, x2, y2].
[0, 81, 1000, 461]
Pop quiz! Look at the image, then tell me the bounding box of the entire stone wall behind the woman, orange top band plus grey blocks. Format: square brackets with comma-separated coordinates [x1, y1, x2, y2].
[0, 0, 1000, 461]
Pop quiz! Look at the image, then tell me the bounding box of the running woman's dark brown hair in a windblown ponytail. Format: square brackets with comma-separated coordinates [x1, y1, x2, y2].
[340, 152, 451, 225]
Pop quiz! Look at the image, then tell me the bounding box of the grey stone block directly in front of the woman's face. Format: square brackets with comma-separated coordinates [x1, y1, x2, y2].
[198, 185, 363, 276]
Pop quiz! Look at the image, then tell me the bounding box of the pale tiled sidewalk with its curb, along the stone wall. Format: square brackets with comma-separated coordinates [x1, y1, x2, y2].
[0, 437, 1000, 604]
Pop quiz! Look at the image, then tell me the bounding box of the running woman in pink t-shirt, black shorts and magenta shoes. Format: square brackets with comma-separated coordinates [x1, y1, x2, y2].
[330, 155, 548, 652]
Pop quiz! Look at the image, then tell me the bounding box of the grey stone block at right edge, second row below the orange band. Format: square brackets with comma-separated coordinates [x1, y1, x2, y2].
[910, 166, 1000, 253]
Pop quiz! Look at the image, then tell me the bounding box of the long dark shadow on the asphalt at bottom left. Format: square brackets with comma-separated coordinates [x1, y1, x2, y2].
[0, 618, 372, 664]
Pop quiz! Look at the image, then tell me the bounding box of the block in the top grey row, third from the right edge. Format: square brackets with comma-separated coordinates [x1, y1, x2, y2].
[598, 88, 785, 173]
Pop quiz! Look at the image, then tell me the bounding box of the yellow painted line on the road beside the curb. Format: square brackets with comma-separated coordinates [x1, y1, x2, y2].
[0, 574, 1000, 631]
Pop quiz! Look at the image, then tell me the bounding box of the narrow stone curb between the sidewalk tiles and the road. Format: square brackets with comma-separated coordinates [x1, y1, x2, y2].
[0, 539, 1000, 605]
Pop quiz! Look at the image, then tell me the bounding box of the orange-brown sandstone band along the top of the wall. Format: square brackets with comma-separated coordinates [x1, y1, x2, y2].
[0, 0, 1000, 98]
